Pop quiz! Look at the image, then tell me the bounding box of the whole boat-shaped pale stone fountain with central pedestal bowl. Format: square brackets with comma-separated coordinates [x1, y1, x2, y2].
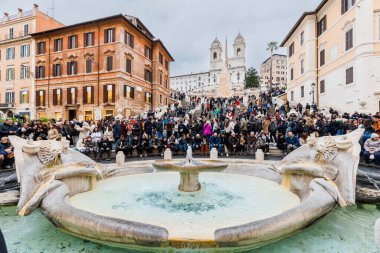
[3, 130, 368, 252]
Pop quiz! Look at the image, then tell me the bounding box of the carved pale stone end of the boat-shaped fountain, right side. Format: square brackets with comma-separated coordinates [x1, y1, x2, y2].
[276, 129, 364, 206]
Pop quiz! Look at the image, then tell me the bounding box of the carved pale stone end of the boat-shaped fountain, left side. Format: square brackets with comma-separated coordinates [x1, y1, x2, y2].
[9, 136, 99, 215]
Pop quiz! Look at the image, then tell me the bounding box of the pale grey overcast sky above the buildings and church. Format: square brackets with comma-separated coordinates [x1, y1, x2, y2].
[0, 0, 321, 76]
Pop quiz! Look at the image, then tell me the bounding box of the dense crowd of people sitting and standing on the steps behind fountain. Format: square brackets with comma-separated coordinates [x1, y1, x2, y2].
[0, 89, 380, 167]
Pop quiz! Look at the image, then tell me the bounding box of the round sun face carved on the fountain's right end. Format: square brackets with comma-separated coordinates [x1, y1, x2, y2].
[310, 136, 338, 163]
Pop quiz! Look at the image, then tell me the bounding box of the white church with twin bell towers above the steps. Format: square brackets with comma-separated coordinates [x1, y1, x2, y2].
[170, 33, 246, 94]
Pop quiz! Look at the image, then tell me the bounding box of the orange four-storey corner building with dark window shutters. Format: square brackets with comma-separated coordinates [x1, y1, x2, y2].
[32, 14, 173, 120]
